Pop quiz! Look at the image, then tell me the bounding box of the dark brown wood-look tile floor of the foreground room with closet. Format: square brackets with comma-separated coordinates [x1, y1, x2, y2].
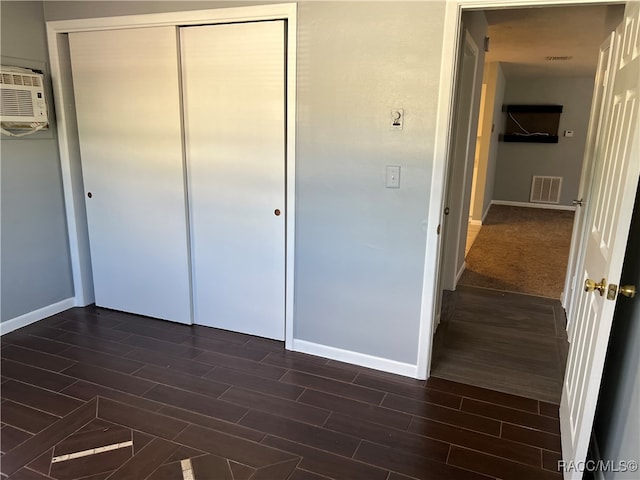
[0, 306, 560, 480]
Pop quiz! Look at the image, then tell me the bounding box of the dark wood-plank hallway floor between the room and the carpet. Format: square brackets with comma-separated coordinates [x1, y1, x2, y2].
[431, 284, 568, 404]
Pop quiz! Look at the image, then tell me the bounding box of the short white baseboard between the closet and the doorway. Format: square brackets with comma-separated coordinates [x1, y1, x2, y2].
[293, 338, 418, 378]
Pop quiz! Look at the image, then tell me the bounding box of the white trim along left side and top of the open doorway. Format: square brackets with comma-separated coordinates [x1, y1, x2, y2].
[417, 0, 607, 379]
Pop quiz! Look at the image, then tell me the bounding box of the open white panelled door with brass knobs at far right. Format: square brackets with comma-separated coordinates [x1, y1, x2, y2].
[560, 2, 640, 480]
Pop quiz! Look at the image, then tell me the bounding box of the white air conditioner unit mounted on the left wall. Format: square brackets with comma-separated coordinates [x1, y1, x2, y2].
[0, 66, 49, 135]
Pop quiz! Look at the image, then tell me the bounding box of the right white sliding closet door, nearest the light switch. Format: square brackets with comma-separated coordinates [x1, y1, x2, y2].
[180, 21, 286, 340]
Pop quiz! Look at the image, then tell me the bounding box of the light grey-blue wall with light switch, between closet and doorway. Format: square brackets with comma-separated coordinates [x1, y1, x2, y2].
[45, 1, 445, 364]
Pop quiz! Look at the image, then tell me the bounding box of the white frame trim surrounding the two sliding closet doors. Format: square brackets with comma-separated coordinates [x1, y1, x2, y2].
[47, 3, 297, 350]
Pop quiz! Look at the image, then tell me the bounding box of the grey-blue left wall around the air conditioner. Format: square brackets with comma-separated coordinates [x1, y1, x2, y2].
[0, 0, 73, 322]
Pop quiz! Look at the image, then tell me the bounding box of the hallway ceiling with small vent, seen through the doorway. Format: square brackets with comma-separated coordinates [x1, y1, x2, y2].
[484, 5, 624, 77]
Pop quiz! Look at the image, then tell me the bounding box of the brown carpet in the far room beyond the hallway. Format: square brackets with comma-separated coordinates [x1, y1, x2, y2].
[459, 205, 574, 298]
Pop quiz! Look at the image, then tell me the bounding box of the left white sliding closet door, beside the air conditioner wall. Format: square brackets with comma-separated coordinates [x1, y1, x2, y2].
[69, 27, 191, 323]
